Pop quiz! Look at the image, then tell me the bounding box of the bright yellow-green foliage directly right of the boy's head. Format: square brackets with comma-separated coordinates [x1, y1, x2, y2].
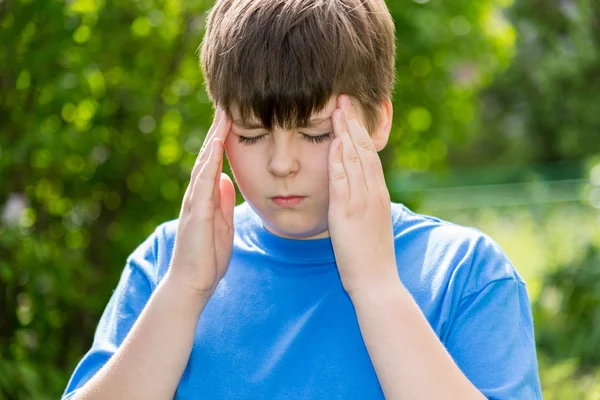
[384, 0, 515, 170]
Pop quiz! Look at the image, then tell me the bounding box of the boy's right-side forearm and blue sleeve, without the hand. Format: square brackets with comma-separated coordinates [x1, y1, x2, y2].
[352, 266, 542, 400]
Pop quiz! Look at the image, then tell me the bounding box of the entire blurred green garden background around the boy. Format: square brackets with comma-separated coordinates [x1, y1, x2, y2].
[0, 0, 600, 399]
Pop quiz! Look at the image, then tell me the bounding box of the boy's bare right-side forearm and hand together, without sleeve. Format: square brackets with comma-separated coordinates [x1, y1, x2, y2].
[328, 96, 485, 399]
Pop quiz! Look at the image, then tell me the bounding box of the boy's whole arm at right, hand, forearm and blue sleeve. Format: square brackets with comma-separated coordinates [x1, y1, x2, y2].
[328, 96, 539, 399]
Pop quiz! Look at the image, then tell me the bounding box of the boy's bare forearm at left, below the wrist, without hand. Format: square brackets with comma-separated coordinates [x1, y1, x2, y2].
[74, 274, 208, 400]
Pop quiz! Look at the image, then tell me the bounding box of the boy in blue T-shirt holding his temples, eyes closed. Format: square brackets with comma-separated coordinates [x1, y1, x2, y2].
[63, 0, 541, 400]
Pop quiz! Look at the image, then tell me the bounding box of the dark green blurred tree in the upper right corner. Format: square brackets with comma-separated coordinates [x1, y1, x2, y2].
[451, 0, 600, 165]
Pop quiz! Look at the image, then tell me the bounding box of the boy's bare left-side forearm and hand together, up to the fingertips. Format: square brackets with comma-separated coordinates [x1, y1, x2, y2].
[73, 112, 235, 400]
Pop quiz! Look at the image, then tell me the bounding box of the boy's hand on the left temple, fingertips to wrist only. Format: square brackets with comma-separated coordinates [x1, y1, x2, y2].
[169, 109, 235, 297]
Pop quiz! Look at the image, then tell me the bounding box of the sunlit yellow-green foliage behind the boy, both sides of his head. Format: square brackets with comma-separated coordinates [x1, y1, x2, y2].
[0, 0, 514, 400]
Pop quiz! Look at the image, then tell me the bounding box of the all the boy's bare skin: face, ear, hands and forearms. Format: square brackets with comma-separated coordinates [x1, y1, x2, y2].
[74, 96, 484, 400]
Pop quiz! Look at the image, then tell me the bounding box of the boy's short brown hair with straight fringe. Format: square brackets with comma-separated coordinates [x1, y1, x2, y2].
[200, 0, 395, 132]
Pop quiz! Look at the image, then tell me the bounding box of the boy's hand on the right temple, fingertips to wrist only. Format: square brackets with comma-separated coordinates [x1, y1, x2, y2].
[328, 95, 398, 296]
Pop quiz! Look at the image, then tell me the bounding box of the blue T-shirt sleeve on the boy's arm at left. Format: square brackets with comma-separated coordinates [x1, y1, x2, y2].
[61, 232, 157, 400]
